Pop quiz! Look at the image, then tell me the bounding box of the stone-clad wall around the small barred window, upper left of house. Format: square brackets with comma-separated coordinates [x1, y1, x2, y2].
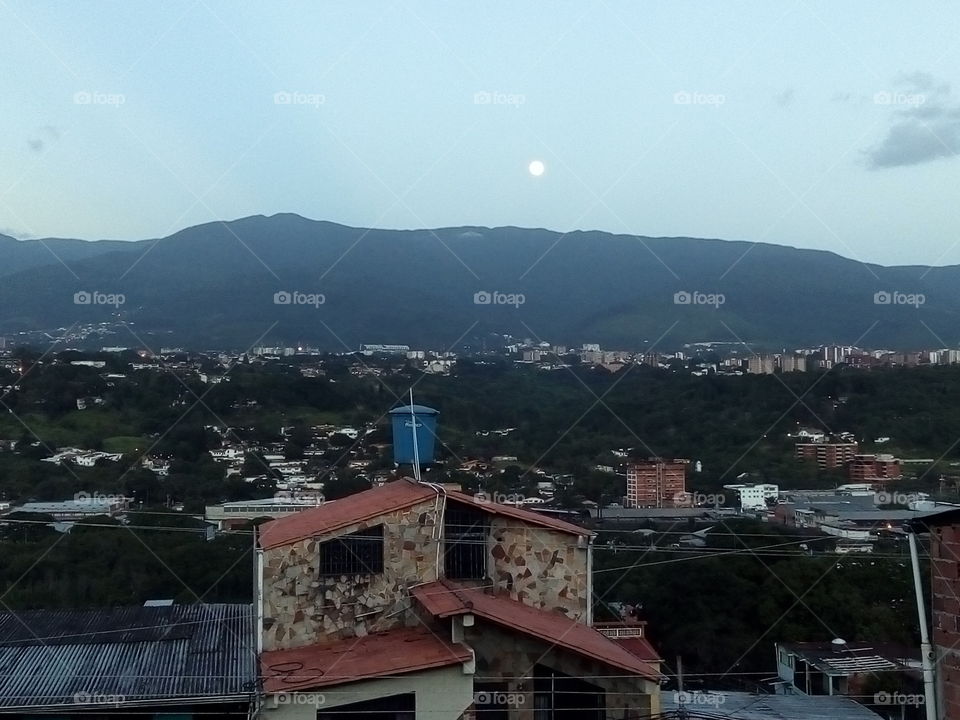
[263, 500, 438, 650]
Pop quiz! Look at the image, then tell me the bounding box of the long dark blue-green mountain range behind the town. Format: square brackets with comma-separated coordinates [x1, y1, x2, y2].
[0, 214, 960, 351]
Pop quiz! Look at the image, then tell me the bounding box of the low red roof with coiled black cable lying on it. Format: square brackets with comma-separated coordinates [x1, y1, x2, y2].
[260, 627, 473, 693]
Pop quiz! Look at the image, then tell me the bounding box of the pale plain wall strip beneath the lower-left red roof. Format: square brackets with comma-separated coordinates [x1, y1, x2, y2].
[258, 665, 473, 720]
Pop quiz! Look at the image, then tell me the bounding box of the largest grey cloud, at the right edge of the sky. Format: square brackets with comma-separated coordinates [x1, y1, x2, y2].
[866, 72, 960, 170]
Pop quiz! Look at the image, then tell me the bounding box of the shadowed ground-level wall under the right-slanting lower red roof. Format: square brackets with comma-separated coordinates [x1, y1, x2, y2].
[464, 619, 660, 720]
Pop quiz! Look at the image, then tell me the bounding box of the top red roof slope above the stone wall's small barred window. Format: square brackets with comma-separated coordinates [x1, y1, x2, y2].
[260, 480, 437, 549]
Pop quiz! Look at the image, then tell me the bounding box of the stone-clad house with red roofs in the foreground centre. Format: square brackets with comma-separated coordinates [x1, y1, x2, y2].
[256, 479, 662, 720]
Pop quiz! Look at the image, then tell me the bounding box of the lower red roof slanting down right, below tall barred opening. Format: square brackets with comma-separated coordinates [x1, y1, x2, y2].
[413, 580, 662, 680]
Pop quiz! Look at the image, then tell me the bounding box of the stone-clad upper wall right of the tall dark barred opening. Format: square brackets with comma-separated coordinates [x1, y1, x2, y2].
[489, 517, 590, 618]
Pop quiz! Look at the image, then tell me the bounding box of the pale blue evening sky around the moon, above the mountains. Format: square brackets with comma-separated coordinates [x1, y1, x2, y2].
[0, 0, 960, 265]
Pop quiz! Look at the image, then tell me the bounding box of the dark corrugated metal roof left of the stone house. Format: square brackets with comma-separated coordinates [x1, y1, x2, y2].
[0, 604, 257, 708]
